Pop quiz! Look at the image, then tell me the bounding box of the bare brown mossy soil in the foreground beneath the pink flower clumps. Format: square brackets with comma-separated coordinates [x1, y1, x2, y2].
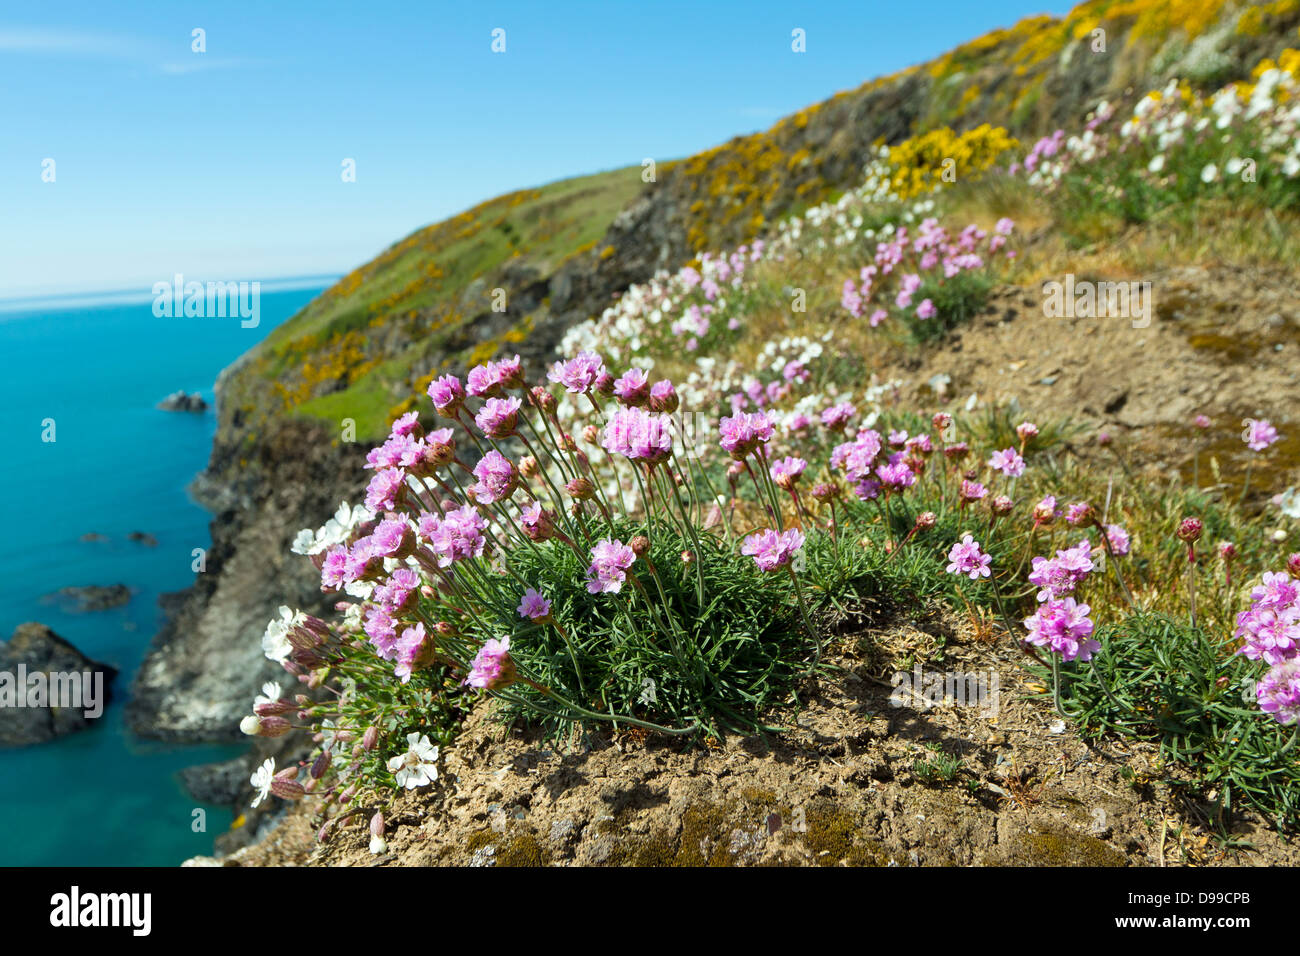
[192, 611, 1300, 866]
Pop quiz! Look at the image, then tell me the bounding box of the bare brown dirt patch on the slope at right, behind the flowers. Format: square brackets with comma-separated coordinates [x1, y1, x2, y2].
[880, 267, 1300, 493]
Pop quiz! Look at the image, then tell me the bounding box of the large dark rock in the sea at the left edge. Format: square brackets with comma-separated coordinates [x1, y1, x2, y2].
[0, 622, 117, 747]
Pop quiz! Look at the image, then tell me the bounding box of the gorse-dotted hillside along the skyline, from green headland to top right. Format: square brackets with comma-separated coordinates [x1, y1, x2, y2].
[213, 0, 1300, 460]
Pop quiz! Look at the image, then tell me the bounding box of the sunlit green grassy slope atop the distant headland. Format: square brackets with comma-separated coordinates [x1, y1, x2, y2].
[224, 166, 642, 436]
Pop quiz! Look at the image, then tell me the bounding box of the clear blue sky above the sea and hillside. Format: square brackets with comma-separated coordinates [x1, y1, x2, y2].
[0, 0, 1070, 298]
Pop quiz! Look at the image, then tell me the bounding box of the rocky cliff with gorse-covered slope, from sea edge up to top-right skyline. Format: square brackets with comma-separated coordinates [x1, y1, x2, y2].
[129, 0, 1300, 740]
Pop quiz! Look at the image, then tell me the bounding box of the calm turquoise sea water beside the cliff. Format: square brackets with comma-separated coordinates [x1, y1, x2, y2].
[0, 280, 328, 866]
